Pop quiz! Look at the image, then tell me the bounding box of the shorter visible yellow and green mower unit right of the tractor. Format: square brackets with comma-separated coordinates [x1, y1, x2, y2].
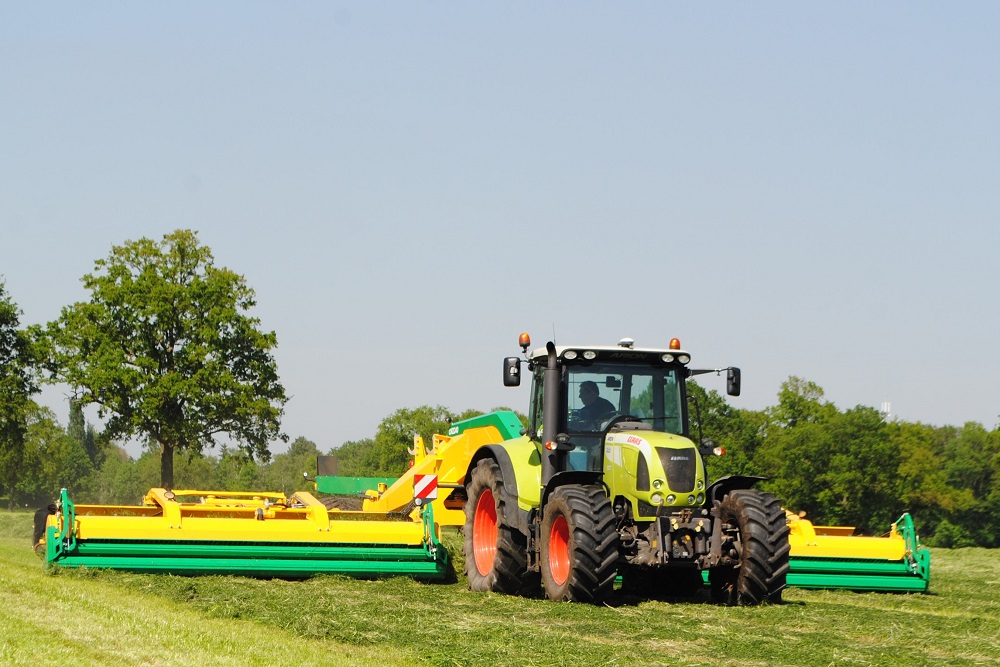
[786, 510, 931, 592]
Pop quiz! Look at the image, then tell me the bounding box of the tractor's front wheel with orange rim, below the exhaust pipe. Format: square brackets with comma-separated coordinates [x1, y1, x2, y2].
[539, 484, 618, 603]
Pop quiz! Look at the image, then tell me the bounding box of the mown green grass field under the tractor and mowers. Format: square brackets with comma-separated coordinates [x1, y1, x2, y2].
[0, 512, 1000, 667]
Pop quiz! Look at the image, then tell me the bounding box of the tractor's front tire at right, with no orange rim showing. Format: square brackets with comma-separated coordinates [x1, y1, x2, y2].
[708, 489, 789, 605]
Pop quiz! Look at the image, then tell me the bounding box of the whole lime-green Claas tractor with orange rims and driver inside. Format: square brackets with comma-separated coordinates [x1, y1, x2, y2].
[464, 334, 789, 605]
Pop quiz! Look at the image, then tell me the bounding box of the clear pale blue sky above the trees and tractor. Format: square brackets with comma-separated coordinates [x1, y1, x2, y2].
[0, 0, 1000, 451]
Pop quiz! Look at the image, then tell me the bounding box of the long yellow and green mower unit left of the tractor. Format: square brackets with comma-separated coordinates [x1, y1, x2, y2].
[36, 489, 449, 579]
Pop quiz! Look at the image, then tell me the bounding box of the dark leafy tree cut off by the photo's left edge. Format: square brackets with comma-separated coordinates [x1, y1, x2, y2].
[0, 280, 38, 507]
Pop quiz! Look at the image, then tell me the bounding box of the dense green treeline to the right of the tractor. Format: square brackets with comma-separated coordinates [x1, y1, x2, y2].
[692, 377, 1000, 547]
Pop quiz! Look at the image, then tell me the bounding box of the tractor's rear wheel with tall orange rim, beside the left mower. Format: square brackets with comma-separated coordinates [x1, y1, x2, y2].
[463, 459, 538, 595]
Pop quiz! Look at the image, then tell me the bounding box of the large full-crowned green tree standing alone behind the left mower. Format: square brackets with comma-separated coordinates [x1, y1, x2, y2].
[46, 230, 287, 488]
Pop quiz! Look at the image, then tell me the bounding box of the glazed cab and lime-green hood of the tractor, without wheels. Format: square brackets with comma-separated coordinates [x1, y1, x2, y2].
[504, 338, 739, 519]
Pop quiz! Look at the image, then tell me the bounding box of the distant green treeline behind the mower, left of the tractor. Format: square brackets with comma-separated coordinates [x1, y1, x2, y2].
[0, 401, 503, 508]
